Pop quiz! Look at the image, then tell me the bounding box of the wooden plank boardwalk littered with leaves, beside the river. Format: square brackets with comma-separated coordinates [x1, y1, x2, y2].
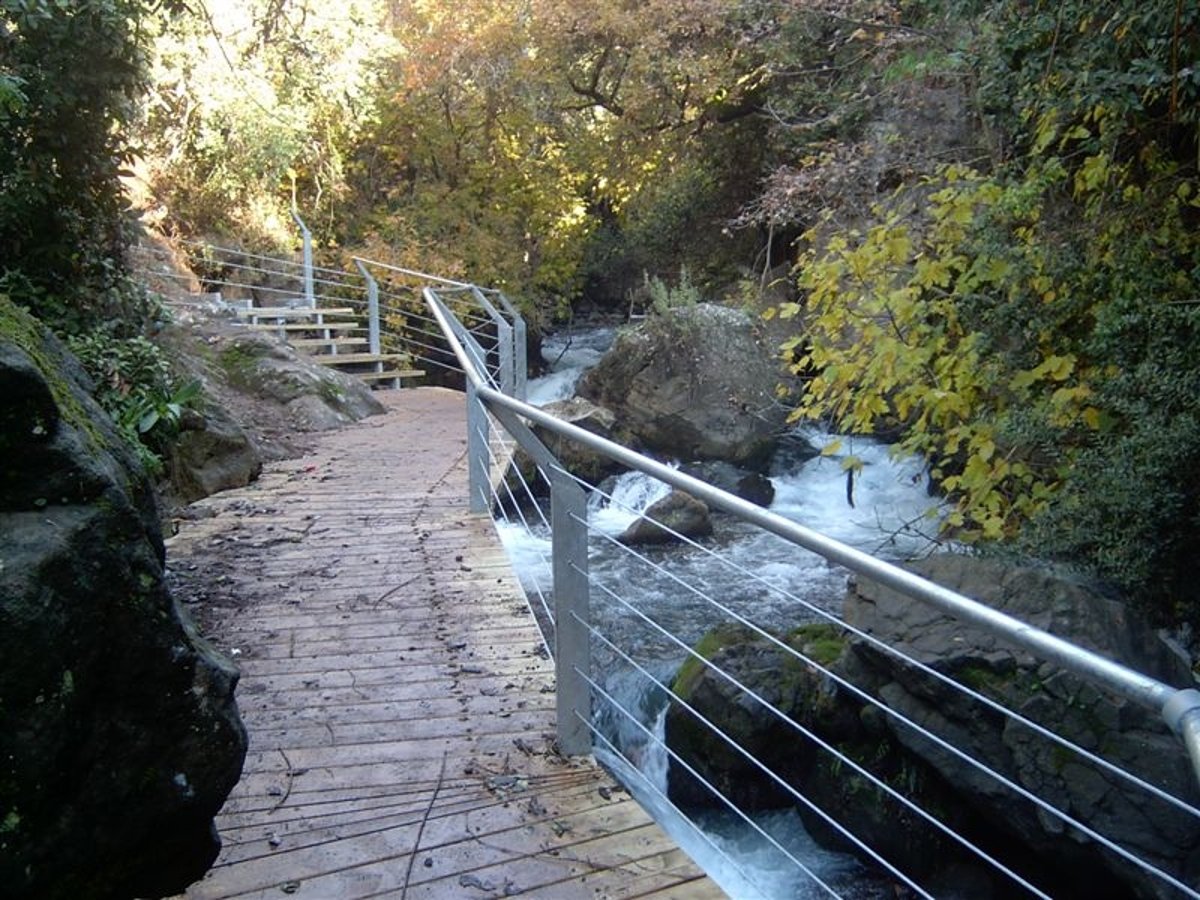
[168, 388, 724, 900]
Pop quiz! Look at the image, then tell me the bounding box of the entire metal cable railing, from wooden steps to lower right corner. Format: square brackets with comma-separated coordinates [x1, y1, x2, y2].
[142, 229, 1200, 899]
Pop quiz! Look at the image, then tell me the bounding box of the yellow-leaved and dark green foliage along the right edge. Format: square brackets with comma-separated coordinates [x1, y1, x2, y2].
[770, 1, 1200, 620]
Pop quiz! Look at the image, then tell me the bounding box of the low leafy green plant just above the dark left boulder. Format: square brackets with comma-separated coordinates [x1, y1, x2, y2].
[68, 331, 200, 474]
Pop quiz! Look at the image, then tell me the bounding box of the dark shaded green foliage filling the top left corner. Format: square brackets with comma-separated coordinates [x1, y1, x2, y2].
[0, 0, 144, 328]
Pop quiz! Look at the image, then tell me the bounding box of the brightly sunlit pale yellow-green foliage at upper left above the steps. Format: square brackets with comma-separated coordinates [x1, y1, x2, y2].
[140, 0, 394, 247]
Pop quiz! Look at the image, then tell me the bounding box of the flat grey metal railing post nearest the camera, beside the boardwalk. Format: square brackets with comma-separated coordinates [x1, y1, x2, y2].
[550, 469, 592, 756]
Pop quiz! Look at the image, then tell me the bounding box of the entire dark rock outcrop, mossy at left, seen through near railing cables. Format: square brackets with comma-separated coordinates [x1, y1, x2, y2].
[667, 556, 1200, 900]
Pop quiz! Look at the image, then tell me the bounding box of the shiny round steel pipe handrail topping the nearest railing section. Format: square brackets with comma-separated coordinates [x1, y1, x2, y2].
[425, 288, 1200, 781]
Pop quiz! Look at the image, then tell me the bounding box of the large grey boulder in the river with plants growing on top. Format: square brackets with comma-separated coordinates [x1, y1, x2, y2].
[580, 304, 787, 466]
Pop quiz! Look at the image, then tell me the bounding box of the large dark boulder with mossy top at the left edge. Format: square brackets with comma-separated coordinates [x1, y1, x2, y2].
[0, 298, 246, 900]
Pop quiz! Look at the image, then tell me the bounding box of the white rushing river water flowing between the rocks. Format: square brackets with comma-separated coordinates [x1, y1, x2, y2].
[499, 329, 936, 900]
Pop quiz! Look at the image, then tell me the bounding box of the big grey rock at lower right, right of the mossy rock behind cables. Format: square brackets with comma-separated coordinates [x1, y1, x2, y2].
[845, 556, 1200, 896]
